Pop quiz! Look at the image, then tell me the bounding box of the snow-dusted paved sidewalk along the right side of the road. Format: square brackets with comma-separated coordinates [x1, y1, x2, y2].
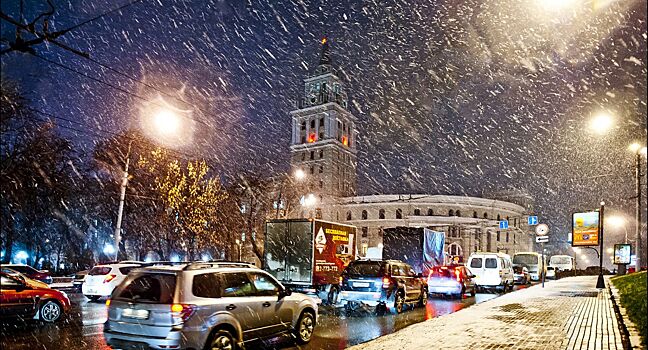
[351, 276, 623, 350]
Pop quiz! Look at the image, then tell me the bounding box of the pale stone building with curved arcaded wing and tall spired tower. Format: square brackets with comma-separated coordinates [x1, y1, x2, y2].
[288, 39, 533, 259]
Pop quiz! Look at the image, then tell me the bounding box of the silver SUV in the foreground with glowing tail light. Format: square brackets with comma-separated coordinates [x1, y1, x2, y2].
[104, 262, 317, 350]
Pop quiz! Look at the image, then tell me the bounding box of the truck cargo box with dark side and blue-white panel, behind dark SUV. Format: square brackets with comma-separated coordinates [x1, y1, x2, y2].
[382, 227, 445, 276]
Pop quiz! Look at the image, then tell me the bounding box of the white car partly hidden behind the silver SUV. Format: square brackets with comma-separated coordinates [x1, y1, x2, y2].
[81, 263, 142, 301]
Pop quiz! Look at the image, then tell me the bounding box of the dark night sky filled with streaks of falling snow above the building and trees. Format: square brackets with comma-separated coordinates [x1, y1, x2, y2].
[2, 0, 647, 252]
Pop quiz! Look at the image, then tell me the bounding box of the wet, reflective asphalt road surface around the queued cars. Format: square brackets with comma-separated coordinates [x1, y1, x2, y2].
[0, 287, 519, 350]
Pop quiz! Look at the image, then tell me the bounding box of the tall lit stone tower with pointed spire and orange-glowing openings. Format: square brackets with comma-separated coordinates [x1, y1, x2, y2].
[290, 37, 357, 219]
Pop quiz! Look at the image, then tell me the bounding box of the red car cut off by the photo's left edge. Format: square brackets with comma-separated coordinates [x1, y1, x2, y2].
[0, 272, 70, 322]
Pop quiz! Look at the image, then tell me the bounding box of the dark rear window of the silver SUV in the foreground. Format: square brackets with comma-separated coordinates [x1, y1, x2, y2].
[114, 273, 176, 304]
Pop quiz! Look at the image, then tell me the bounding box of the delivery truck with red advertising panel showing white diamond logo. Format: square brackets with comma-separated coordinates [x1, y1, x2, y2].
[263, 219, 356, 304]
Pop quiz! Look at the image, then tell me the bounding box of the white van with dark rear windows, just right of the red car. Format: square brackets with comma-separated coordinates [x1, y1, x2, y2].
[467, 252, 514, 292]
